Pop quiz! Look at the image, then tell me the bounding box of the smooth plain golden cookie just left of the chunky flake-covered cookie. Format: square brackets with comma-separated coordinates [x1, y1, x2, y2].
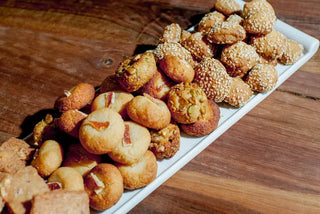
[127, 94, 171, 130]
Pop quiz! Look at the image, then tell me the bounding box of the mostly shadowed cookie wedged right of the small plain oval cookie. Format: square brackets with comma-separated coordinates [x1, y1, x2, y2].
[62, 144, 101, 176]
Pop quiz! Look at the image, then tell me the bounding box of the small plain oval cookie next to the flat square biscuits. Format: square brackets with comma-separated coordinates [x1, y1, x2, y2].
[31, 140, 63, 177]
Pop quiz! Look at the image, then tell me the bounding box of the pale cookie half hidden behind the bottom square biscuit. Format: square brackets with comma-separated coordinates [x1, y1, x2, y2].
[48, 167, 84, 190]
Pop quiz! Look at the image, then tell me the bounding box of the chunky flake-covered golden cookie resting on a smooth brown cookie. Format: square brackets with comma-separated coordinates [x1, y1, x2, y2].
[167, 83, 208, 124]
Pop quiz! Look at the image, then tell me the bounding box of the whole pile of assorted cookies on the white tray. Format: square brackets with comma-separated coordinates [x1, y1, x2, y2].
[0, 0, 303, 213]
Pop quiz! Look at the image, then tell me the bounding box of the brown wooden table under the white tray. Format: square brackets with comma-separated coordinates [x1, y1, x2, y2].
[0, 0, 320, 213]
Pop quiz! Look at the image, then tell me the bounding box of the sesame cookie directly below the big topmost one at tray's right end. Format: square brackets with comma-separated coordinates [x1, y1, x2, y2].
[250, 30, 286, 59]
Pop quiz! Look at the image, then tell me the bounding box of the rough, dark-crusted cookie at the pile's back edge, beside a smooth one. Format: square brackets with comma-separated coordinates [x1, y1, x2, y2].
[115, 52, 157, 92]
